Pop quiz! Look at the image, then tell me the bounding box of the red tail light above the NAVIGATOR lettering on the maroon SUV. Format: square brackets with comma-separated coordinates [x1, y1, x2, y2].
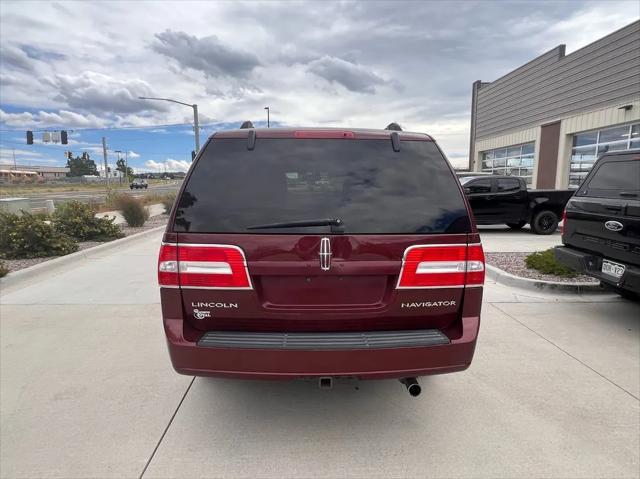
[398, 243, 484, 288]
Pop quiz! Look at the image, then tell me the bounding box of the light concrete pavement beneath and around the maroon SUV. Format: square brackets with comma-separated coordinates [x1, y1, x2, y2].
[0, 233, 640, 478]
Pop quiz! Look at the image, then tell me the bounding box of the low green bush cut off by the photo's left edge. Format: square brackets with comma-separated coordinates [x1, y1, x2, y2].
[0, 212, 78, 259]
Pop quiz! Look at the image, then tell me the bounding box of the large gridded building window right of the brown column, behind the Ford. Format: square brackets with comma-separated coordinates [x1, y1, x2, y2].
[569, 123, 640, 188]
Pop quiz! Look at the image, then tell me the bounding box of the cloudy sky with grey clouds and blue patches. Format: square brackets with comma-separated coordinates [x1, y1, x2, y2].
[0, 0, 640, 170]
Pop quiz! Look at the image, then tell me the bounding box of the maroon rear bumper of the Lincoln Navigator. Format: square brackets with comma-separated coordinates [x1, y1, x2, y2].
[164, 317, 480, 379]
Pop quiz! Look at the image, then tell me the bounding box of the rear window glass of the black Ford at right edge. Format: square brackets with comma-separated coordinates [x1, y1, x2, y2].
[578, 159, 640, 198]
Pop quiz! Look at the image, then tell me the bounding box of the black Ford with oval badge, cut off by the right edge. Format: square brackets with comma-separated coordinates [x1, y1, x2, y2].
[555, 149, 640, 297]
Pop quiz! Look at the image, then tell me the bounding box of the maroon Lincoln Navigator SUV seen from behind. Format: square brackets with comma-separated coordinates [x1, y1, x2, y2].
[158, 128, 484, 395]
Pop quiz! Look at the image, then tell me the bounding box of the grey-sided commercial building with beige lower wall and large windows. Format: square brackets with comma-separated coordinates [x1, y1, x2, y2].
[469, 21, 640, 188]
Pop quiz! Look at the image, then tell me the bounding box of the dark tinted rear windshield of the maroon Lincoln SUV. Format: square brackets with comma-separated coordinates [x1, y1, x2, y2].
[174, 139, 470, 234]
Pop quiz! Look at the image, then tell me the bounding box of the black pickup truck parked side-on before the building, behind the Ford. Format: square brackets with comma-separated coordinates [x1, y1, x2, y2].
[460, 175, 575, 235]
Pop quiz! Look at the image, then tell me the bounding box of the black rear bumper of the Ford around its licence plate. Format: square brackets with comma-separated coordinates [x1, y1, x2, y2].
[555, 246, 640, 293]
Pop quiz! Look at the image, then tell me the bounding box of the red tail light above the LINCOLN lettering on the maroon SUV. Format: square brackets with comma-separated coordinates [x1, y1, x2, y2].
[158, 243, 252, 289]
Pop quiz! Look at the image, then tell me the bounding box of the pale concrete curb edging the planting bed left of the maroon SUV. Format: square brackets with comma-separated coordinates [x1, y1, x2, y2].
[0, 225, 166, 288]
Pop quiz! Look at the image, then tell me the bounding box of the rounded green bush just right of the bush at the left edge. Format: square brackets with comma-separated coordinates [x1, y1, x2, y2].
[53, 201, 124, 241]
